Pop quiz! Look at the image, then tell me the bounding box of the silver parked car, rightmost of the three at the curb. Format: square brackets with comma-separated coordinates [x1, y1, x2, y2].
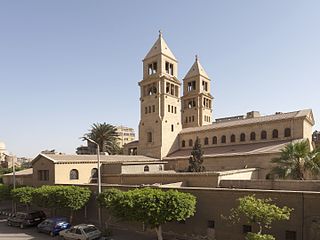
[59, 224, 101, 240]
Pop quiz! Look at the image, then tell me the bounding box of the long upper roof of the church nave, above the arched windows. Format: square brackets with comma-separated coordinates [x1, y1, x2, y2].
[180, 109, 314, 134]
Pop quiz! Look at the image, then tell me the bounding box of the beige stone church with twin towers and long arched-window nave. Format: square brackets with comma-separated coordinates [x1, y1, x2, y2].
[125, 32, 314, 177]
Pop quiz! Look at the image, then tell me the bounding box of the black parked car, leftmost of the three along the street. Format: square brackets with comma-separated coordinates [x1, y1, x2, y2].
[7, 211, 46, 228]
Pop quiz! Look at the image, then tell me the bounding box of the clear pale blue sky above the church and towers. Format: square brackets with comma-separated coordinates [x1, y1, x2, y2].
[0, 0, 320, 158]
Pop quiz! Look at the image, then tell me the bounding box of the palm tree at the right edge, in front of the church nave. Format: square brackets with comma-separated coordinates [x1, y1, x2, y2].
[271, 140, 320, 180]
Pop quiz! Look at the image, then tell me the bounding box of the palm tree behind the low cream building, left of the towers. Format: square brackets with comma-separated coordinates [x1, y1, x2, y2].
[85, 122, 120, 154]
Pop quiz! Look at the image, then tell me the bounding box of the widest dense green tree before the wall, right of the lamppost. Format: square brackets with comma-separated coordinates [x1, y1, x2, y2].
[98, 188, 196, 240]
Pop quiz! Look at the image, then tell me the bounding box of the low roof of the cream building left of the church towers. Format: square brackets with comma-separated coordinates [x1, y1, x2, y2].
[32, 153, 159, 164]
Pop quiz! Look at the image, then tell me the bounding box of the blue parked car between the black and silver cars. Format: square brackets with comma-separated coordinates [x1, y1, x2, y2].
[37, 217, 71, 237]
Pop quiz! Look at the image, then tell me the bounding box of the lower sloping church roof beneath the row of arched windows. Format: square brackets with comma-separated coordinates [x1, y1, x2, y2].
[164, 140, 291, 160]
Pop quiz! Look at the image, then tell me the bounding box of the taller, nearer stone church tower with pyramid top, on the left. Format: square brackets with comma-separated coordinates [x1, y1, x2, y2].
[138, 32, 182, 159]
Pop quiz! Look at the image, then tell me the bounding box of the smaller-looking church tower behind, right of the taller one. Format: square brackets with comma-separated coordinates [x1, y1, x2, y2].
[181, 56, 213, 128]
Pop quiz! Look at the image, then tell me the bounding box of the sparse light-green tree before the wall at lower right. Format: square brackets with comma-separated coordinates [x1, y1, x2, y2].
[227, 195, 293, 240]
